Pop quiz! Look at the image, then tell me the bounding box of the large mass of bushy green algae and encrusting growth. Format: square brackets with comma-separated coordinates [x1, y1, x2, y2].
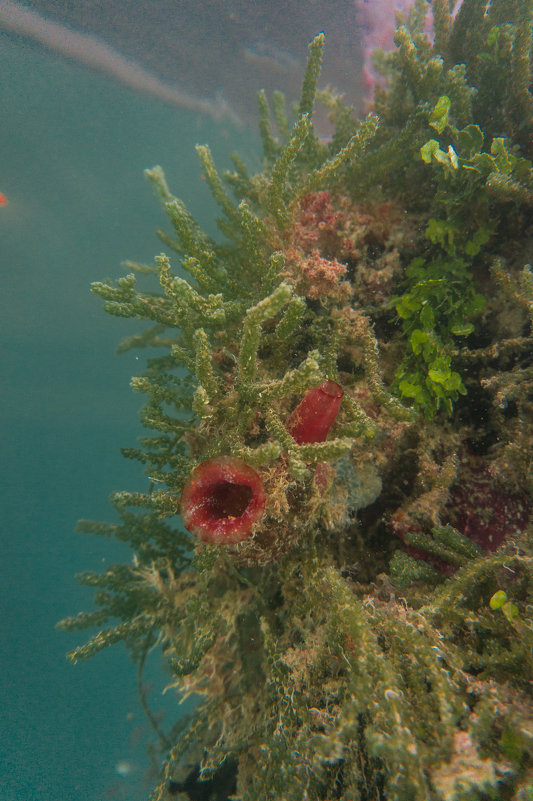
[61, 0, 533, 801]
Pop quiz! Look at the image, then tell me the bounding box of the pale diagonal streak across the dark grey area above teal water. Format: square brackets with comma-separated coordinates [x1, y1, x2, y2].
[0, 0, 240, 123]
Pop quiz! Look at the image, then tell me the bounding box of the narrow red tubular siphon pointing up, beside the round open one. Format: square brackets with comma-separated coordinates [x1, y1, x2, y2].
[288, 381, 344, 445]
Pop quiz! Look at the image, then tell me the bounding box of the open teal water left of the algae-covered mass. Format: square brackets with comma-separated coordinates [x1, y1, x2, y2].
[0, 34, 255, 801]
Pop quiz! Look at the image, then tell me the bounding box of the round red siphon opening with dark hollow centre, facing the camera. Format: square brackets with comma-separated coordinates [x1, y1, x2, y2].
[180, 456, 265, 545]
